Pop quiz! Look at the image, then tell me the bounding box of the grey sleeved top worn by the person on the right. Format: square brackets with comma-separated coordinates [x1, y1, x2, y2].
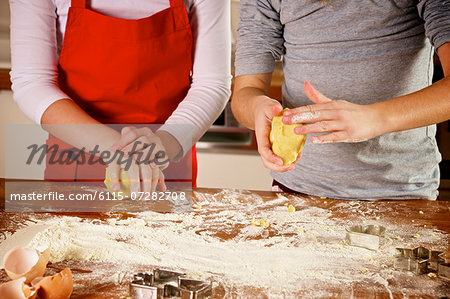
[235, 0, 450, 199]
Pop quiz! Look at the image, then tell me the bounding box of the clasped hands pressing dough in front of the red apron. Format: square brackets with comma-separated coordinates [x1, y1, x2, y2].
[109, 126, 169, 193]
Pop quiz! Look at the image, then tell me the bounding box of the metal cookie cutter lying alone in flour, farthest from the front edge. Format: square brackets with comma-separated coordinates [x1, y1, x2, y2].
[346, 225, 386, 250]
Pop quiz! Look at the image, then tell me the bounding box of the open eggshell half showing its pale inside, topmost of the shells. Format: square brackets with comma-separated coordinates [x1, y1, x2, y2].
[3, 247, 50, 283]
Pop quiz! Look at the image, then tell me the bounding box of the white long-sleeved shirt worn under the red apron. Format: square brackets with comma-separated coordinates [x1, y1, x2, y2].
[9, 0, 231, 158]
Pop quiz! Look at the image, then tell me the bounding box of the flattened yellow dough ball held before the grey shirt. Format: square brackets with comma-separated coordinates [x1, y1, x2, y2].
[270, 108, 306, 165]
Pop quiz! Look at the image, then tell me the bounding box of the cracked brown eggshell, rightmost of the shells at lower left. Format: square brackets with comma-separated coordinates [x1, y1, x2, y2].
[31, 268, 73, 299]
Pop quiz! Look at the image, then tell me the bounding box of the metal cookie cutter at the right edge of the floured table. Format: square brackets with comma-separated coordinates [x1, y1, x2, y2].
[394, 246, 444, 274]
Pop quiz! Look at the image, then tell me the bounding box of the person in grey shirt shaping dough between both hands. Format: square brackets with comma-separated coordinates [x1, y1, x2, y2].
[232, 0, 450, 200]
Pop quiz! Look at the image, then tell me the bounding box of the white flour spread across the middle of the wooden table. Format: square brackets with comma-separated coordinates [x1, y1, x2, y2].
[26, 190, 445, 297]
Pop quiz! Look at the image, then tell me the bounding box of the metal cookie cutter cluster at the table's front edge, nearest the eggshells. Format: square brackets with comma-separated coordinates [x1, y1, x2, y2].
[130, 269, 212, 299]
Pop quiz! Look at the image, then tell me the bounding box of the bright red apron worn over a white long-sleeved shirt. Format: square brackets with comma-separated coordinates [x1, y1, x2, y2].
[45, 0, 197, 186]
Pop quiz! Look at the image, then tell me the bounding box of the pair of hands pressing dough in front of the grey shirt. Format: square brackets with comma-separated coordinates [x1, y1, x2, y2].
[254, 81, 382, 172]
